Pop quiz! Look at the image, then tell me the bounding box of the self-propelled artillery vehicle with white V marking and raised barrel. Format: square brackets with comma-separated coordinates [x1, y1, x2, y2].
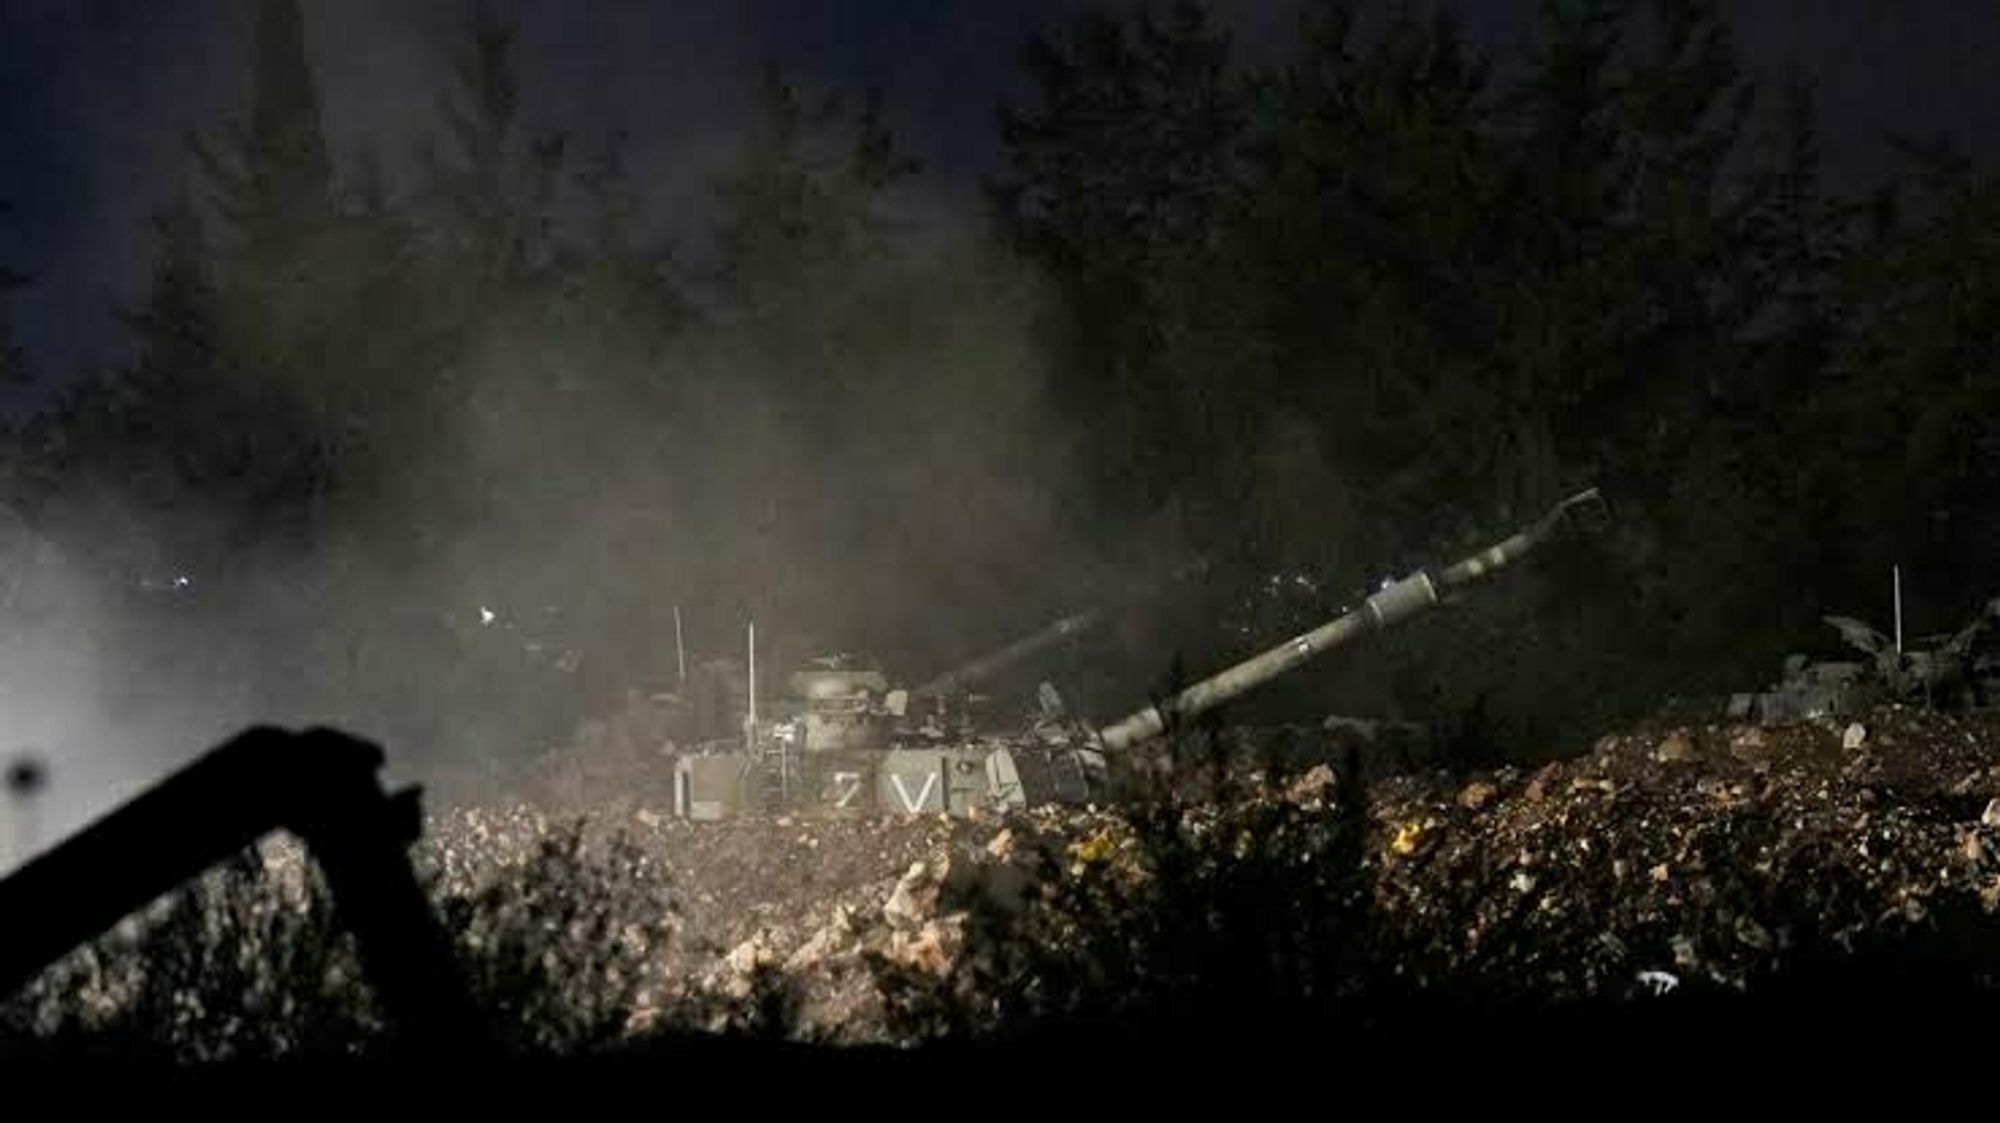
[674, 490, 1604, 819]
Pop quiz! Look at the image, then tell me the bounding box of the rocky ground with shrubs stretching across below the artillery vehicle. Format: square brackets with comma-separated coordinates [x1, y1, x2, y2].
[15, 709, 2000, 1055]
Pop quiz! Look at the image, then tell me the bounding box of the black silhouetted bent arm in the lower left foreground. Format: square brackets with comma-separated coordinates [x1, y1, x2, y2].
[0, 727, 482, 1053]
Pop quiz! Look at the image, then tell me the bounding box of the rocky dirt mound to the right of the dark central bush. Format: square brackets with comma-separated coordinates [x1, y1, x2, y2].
[1370, 709, 2000, 997]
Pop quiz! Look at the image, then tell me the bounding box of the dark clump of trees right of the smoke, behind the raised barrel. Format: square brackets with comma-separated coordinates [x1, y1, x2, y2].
[996, 0, 2000, 739]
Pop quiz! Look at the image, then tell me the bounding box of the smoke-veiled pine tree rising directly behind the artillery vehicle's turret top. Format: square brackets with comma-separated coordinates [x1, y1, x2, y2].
[678, 66, 916, 631]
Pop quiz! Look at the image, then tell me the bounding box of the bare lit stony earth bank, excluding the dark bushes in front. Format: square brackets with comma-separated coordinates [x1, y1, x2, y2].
[402, 709, 2000, 1041]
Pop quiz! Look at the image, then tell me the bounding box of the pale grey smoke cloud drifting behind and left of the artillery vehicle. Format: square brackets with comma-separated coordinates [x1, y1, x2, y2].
[4, 0, 1144, 843]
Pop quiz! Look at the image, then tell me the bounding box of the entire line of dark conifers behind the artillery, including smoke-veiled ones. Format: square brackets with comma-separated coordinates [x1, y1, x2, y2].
[0, 0, 2000, 767]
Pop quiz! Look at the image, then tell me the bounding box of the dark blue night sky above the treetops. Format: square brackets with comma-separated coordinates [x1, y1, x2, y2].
[0, 0, 2000, 397]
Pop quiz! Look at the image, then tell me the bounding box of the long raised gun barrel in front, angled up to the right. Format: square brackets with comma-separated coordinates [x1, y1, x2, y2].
[1098, 488, 1602, 751]
